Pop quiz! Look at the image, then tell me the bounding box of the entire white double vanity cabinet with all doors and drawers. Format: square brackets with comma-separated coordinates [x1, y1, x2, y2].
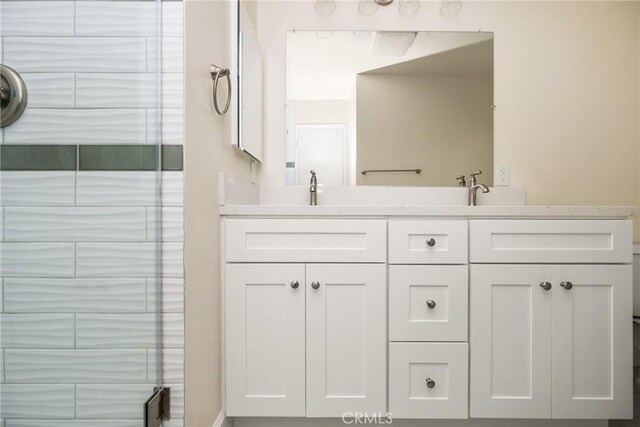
[222, 212, 633, 426]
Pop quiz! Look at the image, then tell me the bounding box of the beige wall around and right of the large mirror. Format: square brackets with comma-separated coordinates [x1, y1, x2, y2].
[258, 1, 640, 240]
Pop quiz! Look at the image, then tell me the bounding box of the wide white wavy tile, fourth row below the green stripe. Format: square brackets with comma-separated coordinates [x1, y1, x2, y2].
[4, 279, 147, 313]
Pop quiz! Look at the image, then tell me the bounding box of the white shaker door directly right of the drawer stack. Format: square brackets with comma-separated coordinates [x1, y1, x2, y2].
[469, 265, 555, 418]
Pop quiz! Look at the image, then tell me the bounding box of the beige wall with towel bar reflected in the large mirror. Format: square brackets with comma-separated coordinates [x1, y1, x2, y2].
[356, 73, 493, 187]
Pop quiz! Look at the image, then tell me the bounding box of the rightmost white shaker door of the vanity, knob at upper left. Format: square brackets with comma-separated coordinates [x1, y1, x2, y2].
[552, 265, 633, 419]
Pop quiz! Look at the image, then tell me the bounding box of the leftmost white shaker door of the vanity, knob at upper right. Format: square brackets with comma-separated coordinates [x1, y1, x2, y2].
[225, 264, 305, 416]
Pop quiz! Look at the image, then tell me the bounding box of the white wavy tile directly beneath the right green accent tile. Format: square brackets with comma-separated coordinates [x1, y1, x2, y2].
[77, 172, 158, 206]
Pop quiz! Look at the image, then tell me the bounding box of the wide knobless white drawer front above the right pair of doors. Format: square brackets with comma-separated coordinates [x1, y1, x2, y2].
[469, 220, 633, 263]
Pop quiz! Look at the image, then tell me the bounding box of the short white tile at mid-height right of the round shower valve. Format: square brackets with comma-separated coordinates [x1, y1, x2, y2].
[21, 73, 75, 108]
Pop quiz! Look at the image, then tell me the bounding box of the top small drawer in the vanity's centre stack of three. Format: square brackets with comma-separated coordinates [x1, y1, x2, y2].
[389, 220, 467, 264]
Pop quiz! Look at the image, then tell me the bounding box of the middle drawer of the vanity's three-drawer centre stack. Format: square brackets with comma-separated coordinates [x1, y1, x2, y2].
[389, 265, 469, 341]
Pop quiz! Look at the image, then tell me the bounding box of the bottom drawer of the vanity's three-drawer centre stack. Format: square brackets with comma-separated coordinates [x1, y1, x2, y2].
[389, 343, 469, 419]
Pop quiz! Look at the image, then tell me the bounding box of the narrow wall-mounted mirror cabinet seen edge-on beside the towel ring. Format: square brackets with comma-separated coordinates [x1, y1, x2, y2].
[232, 0, 263, 161]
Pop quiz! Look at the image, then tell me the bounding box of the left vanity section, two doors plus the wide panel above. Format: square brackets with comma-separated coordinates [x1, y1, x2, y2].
[225, 219, 387, 417]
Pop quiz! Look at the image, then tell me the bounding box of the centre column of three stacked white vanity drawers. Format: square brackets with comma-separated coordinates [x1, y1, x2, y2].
[389, 219, 469, 419]
